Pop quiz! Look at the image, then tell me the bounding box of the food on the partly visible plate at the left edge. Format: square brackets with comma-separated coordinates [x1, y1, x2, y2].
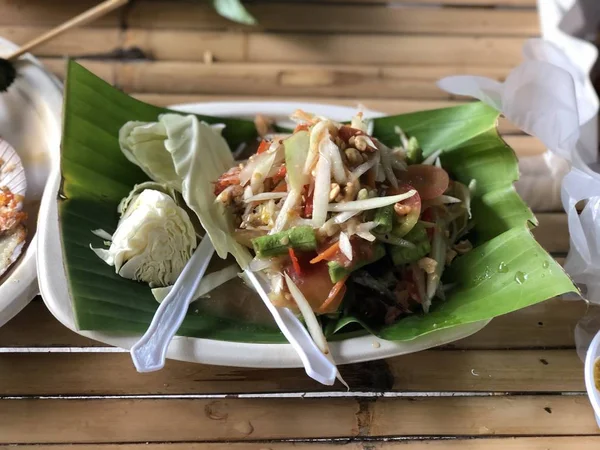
[0, 139, 27, 276]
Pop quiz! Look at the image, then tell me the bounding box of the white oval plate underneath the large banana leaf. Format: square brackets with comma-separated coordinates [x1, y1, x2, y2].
[38, 102, 489, 367]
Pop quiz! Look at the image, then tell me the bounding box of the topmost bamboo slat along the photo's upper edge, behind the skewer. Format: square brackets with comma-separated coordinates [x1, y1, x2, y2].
[0, 0, 538, 29]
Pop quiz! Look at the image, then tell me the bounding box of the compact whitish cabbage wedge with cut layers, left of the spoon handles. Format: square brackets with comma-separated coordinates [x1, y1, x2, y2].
[92, 189, 196, 287]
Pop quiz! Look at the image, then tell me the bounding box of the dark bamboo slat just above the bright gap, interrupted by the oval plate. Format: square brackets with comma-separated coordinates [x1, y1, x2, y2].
[0, 299, 586, 350]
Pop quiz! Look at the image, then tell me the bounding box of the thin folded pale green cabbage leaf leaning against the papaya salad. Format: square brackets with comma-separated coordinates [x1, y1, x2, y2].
[119, 114, 252, 268]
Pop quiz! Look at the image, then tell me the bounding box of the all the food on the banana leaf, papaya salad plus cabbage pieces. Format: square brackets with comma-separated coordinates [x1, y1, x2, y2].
[94, 111, 473, 325]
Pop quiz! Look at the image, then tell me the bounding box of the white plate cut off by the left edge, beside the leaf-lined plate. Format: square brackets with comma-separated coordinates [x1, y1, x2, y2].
[0, 38, 62, 326]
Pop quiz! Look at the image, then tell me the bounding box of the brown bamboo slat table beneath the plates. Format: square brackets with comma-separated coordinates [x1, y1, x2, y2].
[0, 0, 600, 450]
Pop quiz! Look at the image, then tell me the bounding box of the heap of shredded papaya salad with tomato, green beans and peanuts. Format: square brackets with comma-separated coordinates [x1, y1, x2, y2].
[214, 111, 474, 325]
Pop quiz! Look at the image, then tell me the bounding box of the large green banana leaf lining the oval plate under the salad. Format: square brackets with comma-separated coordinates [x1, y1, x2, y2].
[59, 61, 576, 342]
